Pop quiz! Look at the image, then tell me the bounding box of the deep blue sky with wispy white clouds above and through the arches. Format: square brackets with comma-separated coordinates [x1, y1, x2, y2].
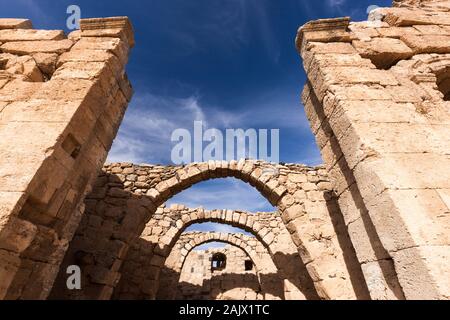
[0, 0, 390, 239]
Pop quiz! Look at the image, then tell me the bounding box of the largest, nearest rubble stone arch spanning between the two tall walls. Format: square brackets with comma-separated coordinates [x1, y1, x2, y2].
[54, 160, 356, 299]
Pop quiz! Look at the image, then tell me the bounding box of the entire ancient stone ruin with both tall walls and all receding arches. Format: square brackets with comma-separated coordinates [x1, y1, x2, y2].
[0, 0, 450, 300]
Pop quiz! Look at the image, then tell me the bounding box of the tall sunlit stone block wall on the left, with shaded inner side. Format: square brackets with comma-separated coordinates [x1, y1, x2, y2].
[0, 17, 133, 299]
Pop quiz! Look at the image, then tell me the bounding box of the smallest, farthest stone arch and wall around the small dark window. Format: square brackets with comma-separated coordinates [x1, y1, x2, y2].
[157, 232, 278, 299]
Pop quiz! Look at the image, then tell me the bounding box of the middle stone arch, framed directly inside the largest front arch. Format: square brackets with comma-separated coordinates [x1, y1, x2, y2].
[115, 204, 318, 299]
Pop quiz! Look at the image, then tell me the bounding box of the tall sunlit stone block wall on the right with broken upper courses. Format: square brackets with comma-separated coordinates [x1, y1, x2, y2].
[297, 1, 450, 299]
